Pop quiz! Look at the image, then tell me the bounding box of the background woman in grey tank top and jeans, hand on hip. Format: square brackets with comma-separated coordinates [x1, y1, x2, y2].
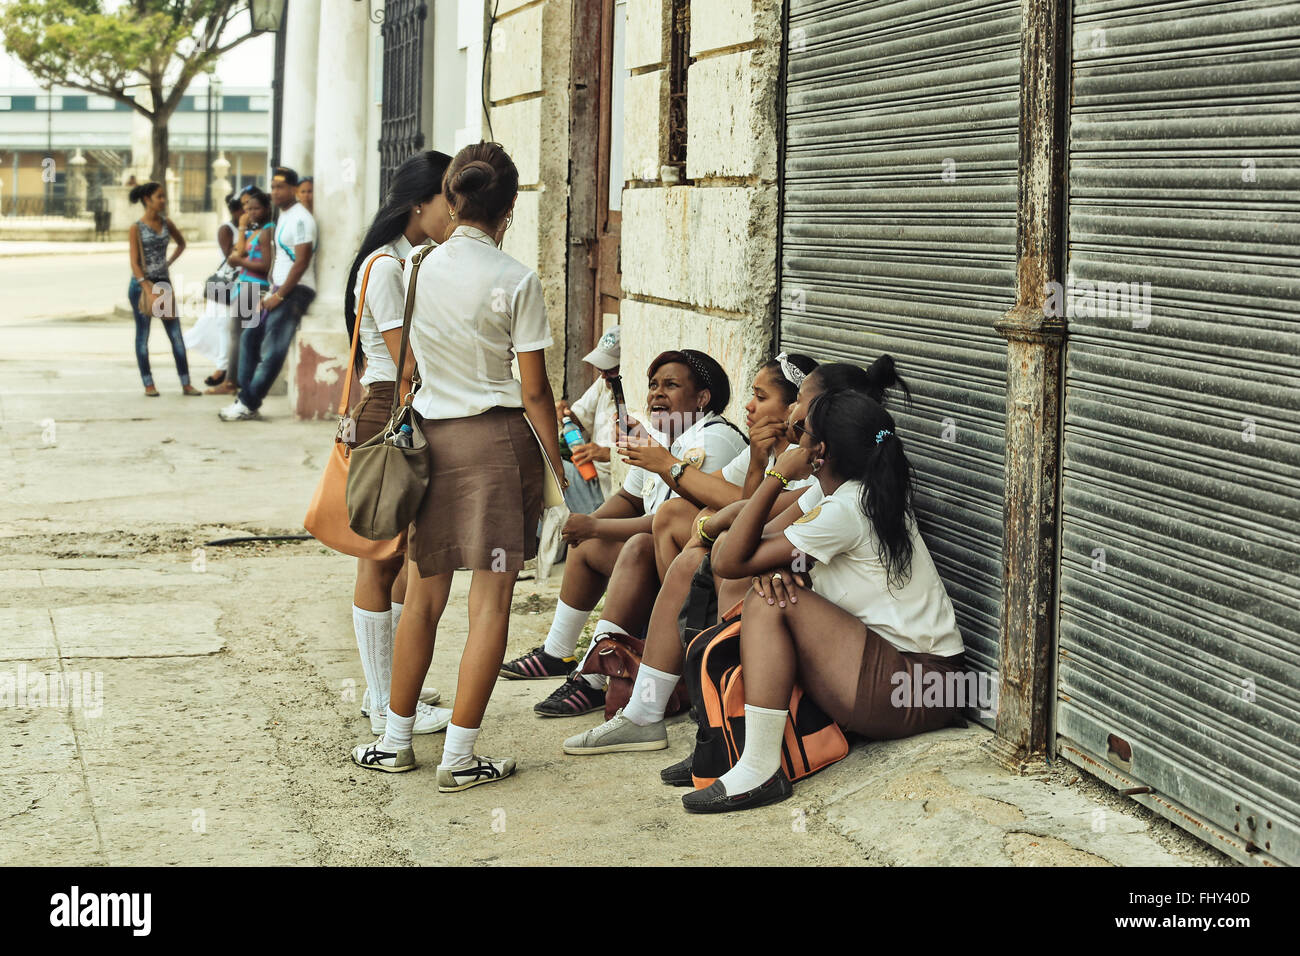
[126, 182, 195, 398]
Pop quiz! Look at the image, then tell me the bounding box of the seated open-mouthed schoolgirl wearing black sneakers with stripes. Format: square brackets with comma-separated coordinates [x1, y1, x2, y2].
[501, 349, 745, 717]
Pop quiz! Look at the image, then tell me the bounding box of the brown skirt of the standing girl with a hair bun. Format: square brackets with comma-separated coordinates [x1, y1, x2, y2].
[407, 406, 545, 578]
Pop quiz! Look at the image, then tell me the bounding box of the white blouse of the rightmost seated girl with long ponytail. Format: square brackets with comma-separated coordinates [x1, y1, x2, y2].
[785, 481, 965, 657]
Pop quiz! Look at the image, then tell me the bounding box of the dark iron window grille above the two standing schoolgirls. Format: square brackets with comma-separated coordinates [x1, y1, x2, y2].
[380, 0, 429, 199]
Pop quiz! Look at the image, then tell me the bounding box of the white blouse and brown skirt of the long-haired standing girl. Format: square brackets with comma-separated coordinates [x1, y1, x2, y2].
[348, 235, 410, 447]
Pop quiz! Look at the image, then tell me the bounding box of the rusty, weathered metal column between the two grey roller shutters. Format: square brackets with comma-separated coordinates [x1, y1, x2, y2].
[988, 0, 1070, 774]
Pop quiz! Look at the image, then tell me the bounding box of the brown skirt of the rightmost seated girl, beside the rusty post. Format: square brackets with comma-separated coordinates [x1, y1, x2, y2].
[847, 628, 979, 740]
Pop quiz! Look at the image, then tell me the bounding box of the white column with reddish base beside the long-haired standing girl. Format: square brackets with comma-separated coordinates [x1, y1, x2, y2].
[286, 0, 377, 419]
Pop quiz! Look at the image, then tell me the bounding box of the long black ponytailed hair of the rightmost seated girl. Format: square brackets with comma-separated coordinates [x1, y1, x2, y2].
[807, 390, 913, 588]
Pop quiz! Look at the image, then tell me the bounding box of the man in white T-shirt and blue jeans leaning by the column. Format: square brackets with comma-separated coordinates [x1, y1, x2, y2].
[218, 166, 316, 421]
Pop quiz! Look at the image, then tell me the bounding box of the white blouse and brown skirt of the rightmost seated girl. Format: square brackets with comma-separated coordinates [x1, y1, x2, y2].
[785, 481, 966, 740]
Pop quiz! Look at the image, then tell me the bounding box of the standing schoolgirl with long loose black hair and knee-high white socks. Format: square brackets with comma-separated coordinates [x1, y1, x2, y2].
[343, 150, 451, 736]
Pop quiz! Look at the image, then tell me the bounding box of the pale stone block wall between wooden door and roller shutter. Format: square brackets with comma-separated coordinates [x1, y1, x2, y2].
[621, 0, 780, 423]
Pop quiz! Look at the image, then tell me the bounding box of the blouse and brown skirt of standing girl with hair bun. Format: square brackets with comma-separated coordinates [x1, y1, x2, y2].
[407, 225, 553, 578]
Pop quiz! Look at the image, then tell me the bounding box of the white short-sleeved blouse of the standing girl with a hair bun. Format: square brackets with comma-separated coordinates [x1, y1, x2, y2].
[403, 226, 553, 419]
